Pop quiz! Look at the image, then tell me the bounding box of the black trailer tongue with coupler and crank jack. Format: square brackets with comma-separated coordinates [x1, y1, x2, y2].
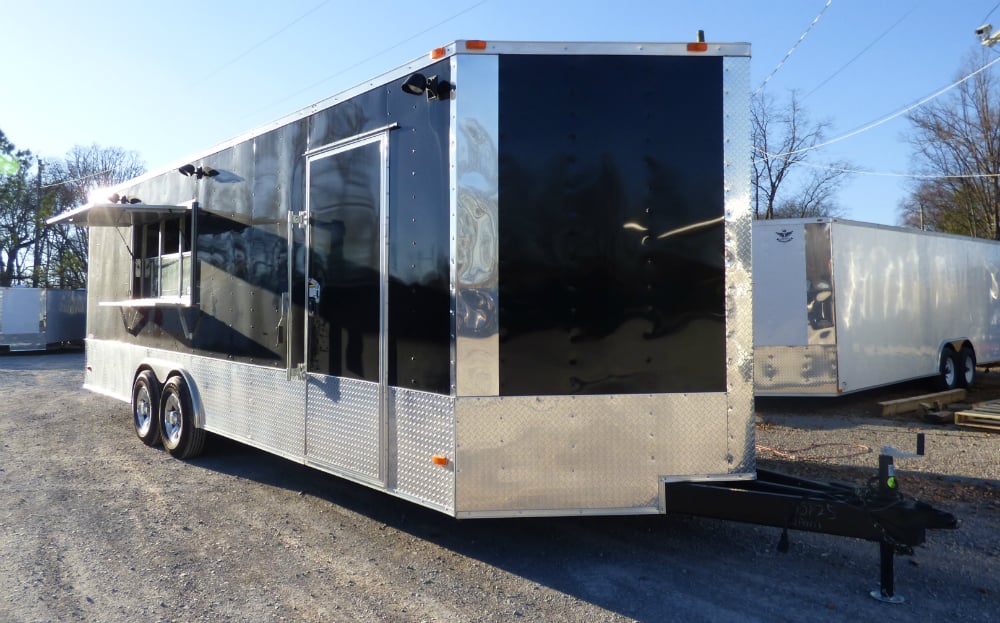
[664, 435, 958, 603]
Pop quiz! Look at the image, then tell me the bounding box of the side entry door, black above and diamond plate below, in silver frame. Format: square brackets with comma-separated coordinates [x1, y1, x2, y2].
[305, 133, 388, 484]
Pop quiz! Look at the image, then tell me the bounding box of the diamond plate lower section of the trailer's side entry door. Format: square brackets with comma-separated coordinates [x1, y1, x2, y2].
[306, 374, 383, 483]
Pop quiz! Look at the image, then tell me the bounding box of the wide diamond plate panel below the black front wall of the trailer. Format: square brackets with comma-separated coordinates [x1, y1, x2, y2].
[455, 393, 733, 516]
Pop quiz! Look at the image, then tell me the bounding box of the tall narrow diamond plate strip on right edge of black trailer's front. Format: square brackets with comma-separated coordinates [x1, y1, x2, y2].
[722, 57, 756, 473]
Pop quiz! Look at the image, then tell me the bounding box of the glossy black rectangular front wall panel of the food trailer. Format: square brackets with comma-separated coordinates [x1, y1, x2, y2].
[499, 55, 726, 395]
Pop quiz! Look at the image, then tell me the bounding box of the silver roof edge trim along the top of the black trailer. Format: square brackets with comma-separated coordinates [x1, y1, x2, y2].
[48, 39, 750, 210]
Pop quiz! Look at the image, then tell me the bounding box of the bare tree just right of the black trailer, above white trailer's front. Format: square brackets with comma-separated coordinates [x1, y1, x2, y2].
[751, 91, 849, 219]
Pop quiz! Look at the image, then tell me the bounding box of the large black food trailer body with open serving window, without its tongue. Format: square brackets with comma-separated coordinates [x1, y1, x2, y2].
[45, 41, 755, 517]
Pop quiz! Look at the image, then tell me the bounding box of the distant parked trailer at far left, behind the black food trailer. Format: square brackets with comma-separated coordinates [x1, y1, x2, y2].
[0, 288, 87, 352]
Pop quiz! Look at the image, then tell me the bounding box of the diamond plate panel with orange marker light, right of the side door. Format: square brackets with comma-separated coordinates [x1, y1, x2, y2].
[389, 387, 455, 512]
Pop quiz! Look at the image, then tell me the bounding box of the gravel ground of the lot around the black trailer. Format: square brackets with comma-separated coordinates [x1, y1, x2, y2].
[0, 353, 1000, 623]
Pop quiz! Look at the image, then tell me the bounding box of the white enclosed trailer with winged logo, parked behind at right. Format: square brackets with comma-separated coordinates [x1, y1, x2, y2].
[753, 219, 1000, 396]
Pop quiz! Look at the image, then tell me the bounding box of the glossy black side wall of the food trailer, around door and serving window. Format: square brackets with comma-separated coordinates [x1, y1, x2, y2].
[88, 62, 451, 394]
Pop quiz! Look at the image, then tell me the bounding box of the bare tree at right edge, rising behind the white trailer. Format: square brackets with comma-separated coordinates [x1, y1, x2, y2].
[900, 52, 1000, 240]
